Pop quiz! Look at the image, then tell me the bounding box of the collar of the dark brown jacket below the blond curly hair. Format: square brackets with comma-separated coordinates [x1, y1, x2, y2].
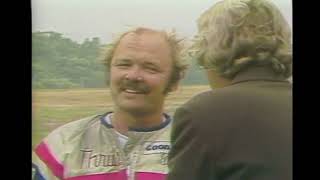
[231, 66, 289, 84]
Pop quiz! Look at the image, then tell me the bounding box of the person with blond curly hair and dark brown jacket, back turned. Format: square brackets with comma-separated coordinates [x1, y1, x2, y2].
[168, 0, 292, 180]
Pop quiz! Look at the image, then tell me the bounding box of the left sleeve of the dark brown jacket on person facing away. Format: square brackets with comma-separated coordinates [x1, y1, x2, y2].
[167, 108, 210, 180]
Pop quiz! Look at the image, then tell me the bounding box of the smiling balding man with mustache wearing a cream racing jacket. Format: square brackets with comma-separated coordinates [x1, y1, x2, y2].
[34, 28, 187, 180]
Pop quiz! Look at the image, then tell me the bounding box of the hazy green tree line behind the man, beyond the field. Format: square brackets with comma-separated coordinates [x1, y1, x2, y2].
[32, 31, 206, 89]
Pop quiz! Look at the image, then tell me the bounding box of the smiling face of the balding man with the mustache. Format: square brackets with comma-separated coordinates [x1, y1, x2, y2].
[110, 32, 173, 114]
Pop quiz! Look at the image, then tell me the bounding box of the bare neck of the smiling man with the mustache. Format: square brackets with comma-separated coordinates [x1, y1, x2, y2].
[111, 111, 163, 135]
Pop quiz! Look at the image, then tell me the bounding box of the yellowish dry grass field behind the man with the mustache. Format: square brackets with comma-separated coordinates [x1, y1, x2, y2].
[32, 86, 209, 147]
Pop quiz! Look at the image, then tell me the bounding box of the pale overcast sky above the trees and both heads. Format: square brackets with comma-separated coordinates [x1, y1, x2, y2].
[31, 0, 292, 43]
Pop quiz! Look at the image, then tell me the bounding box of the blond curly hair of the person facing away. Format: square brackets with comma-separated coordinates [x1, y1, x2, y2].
[189, 0, 292, 78]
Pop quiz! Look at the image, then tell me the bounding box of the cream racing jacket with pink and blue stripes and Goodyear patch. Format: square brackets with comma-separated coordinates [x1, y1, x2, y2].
[32, 112, 171, 180]
